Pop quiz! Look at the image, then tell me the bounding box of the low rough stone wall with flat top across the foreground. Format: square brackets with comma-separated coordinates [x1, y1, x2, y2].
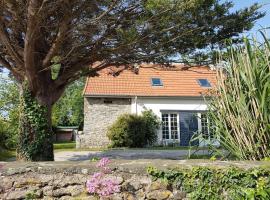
[0, 160, 269, 200]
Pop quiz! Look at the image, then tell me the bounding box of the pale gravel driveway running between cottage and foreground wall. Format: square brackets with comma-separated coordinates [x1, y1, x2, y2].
[54, 150, 208, 161]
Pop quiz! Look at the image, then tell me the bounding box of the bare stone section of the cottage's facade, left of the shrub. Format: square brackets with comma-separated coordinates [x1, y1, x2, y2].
[76, 97, 131, 148]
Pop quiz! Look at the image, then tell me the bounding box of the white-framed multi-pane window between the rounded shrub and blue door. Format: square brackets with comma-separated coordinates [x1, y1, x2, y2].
[161, 113, 180, 140]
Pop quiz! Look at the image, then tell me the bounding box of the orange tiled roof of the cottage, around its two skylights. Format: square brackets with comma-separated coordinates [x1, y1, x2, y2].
[84, 64, 216, 97]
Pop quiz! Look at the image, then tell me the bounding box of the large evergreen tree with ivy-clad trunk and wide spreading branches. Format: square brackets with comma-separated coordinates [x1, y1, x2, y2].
[0, 0, 263, 160]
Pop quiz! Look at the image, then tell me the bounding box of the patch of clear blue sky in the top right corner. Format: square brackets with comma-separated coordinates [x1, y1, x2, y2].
[232, 0, 270, 37]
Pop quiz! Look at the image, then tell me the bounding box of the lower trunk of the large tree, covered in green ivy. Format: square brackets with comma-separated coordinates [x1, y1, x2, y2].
[17, 86, 54, 161]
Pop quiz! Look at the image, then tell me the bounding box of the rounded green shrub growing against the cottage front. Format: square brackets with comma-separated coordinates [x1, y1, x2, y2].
[107, 111, 160, 147]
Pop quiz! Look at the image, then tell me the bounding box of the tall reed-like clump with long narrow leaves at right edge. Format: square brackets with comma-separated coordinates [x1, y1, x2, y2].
[209, 33, 270, 160]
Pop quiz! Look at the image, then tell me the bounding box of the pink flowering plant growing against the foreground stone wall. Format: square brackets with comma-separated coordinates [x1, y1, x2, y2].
[86, 158, 120, 197]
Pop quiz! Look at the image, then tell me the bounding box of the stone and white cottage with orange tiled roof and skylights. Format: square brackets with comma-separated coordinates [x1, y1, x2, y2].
[77, 64, 216, 148]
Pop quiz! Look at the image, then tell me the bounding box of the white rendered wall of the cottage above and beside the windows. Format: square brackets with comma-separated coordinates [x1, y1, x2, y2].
[131, 97, 207, 143]
